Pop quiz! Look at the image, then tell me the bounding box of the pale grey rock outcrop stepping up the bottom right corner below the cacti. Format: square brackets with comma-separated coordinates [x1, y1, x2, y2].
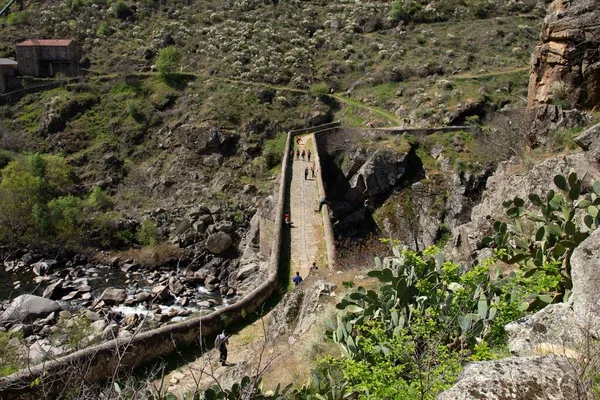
[438, 214, 600, 400]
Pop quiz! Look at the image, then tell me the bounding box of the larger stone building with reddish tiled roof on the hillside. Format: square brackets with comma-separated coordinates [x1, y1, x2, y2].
[17, 39, 79, 78]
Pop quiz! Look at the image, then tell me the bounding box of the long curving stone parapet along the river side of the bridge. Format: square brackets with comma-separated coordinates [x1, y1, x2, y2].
[0, 133, 292, 400]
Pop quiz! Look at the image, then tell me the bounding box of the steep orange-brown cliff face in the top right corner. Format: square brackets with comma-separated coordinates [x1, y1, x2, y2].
[528, 0, 600, 108]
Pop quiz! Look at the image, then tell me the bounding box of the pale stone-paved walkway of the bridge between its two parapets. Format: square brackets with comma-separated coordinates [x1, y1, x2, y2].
[290, 135, 326, 278]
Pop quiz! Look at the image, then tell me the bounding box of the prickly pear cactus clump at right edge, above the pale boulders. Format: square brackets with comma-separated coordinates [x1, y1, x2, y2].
[482, 172, 600, 300]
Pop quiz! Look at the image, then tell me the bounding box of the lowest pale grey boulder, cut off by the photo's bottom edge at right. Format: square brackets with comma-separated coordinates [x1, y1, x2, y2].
[437, 356, 579, 400]
